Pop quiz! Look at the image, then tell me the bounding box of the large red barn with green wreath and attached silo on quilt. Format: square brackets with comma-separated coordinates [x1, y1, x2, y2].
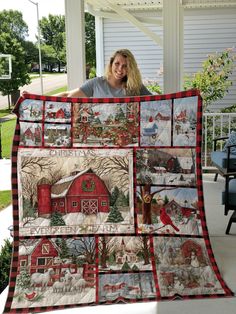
[38, 169, 110, 217]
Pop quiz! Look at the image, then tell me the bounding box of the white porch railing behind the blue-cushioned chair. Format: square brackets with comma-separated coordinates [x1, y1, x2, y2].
[202, 112, 236, 169]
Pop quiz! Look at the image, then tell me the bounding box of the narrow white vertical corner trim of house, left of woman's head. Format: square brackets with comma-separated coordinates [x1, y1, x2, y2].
[95, 16, 105, 76]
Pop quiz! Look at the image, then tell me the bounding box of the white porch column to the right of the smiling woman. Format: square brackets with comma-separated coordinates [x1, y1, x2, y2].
[163, 0, 183, 93]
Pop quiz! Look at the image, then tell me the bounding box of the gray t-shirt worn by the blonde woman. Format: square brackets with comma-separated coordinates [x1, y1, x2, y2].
[80, 76, 152, 98]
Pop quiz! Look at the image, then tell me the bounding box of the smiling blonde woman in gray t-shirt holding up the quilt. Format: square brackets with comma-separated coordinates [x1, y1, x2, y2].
[56, 49, 152, 98]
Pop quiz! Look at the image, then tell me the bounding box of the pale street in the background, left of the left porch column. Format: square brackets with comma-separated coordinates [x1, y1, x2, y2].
[0, 74, 67, 109]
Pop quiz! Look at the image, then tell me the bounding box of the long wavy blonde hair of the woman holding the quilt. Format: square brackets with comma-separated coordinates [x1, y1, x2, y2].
[104, 49, 142, 96]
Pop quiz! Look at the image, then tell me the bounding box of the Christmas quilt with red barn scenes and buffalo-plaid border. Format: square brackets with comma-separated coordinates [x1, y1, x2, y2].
[5, 90, 233, 313]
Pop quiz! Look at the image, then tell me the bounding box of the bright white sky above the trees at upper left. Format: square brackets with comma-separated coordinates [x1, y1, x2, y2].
[0, 0, 65, 42]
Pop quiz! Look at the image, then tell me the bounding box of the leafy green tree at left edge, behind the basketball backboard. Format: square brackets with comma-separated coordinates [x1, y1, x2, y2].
[0, 10, 30, 108]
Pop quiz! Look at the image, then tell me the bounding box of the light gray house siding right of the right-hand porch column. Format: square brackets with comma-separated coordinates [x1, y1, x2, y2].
[184, 8, 236, 112]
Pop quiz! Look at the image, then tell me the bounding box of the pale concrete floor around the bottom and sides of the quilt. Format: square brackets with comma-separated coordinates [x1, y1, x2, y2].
[0, 161, 236, 314]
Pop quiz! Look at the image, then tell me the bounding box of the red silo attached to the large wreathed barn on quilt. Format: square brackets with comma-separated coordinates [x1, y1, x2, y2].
[37, 178, 51, 218]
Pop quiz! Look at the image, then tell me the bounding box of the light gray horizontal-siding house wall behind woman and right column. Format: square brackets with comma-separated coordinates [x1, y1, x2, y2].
[103, 7, 236, 111]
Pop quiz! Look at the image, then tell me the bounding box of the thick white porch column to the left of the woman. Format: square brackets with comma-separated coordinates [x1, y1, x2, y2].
[65, 0, 86, 90]
